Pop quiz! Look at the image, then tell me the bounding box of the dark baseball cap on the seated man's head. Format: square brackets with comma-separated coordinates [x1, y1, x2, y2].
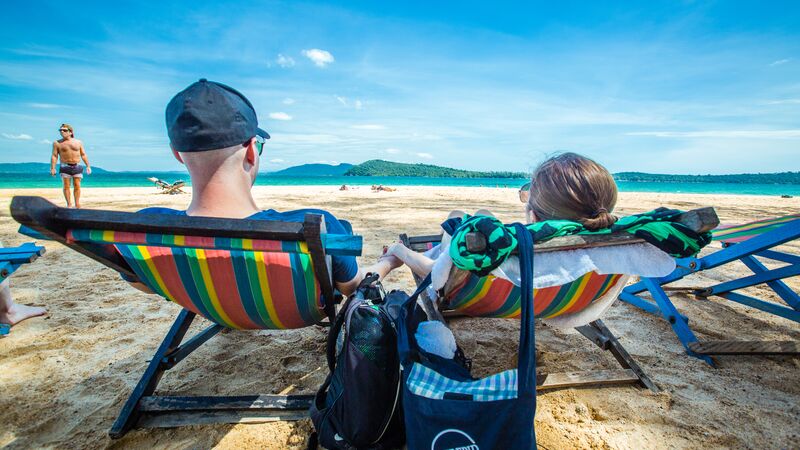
[166, 78, 269, 152]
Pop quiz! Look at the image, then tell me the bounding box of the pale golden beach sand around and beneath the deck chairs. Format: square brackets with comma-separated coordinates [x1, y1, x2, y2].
[0, 186, 800, 449]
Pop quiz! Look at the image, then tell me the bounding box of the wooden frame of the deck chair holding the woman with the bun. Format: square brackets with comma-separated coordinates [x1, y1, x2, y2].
[400, 208, 719, 392]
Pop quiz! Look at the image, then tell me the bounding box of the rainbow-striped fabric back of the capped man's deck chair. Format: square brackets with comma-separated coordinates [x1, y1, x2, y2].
[67, 230, 325, 329]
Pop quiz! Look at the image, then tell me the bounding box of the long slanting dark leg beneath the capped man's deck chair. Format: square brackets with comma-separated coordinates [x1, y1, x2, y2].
[108, 309, 195, 439]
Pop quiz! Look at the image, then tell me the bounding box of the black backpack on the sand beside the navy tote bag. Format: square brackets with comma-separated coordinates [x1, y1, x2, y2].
[309, 275, 408, 450]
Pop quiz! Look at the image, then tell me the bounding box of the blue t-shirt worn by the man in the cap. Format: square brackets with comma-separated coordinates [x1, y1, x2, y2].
[139, 207, 358, 283]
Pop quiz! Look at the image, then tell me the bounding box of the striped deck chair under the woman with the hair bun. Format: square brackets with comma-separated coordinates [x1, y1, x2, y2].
[400, 208, 719, 392]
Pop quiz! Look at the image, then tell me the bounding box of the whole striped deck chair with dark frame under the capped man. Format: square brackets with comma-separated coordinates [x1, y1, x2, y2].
[11, 197, 361, 438]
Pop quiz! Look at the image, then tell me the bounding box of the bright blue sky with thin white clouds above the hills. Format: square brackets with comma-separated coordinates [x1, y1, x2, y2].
[0, 1, 800, 173]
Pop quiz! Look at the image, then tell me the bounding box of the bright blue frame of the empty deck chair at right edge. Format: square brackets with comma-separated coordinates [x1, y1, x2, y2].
[619, 220, 800, 366]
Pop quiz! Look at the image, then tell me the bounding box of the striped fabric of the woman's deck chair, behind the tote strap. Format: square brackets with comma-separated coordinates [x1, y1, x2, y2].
[446, 272, 622, 319]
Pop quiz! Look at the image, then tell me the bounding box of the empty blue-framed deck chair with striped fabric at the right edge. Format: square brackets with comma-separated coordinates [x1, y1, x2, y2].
[620, 214, 800, 366]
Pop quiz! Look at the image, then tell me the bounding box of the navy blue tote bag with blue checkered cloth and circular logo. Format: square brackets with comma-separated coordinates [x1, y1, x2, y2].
[398, 224, 536, 450]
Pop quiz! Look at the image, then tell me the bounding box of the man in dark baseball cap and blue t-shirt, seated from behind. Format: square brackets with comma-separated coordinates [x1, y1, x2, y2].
[142, 78, 401, 295]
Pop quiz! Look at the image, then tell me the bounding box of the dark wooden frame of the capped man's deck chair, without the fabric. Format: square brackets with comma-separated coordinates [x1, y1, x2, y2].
[11, 196, 361, 438]
